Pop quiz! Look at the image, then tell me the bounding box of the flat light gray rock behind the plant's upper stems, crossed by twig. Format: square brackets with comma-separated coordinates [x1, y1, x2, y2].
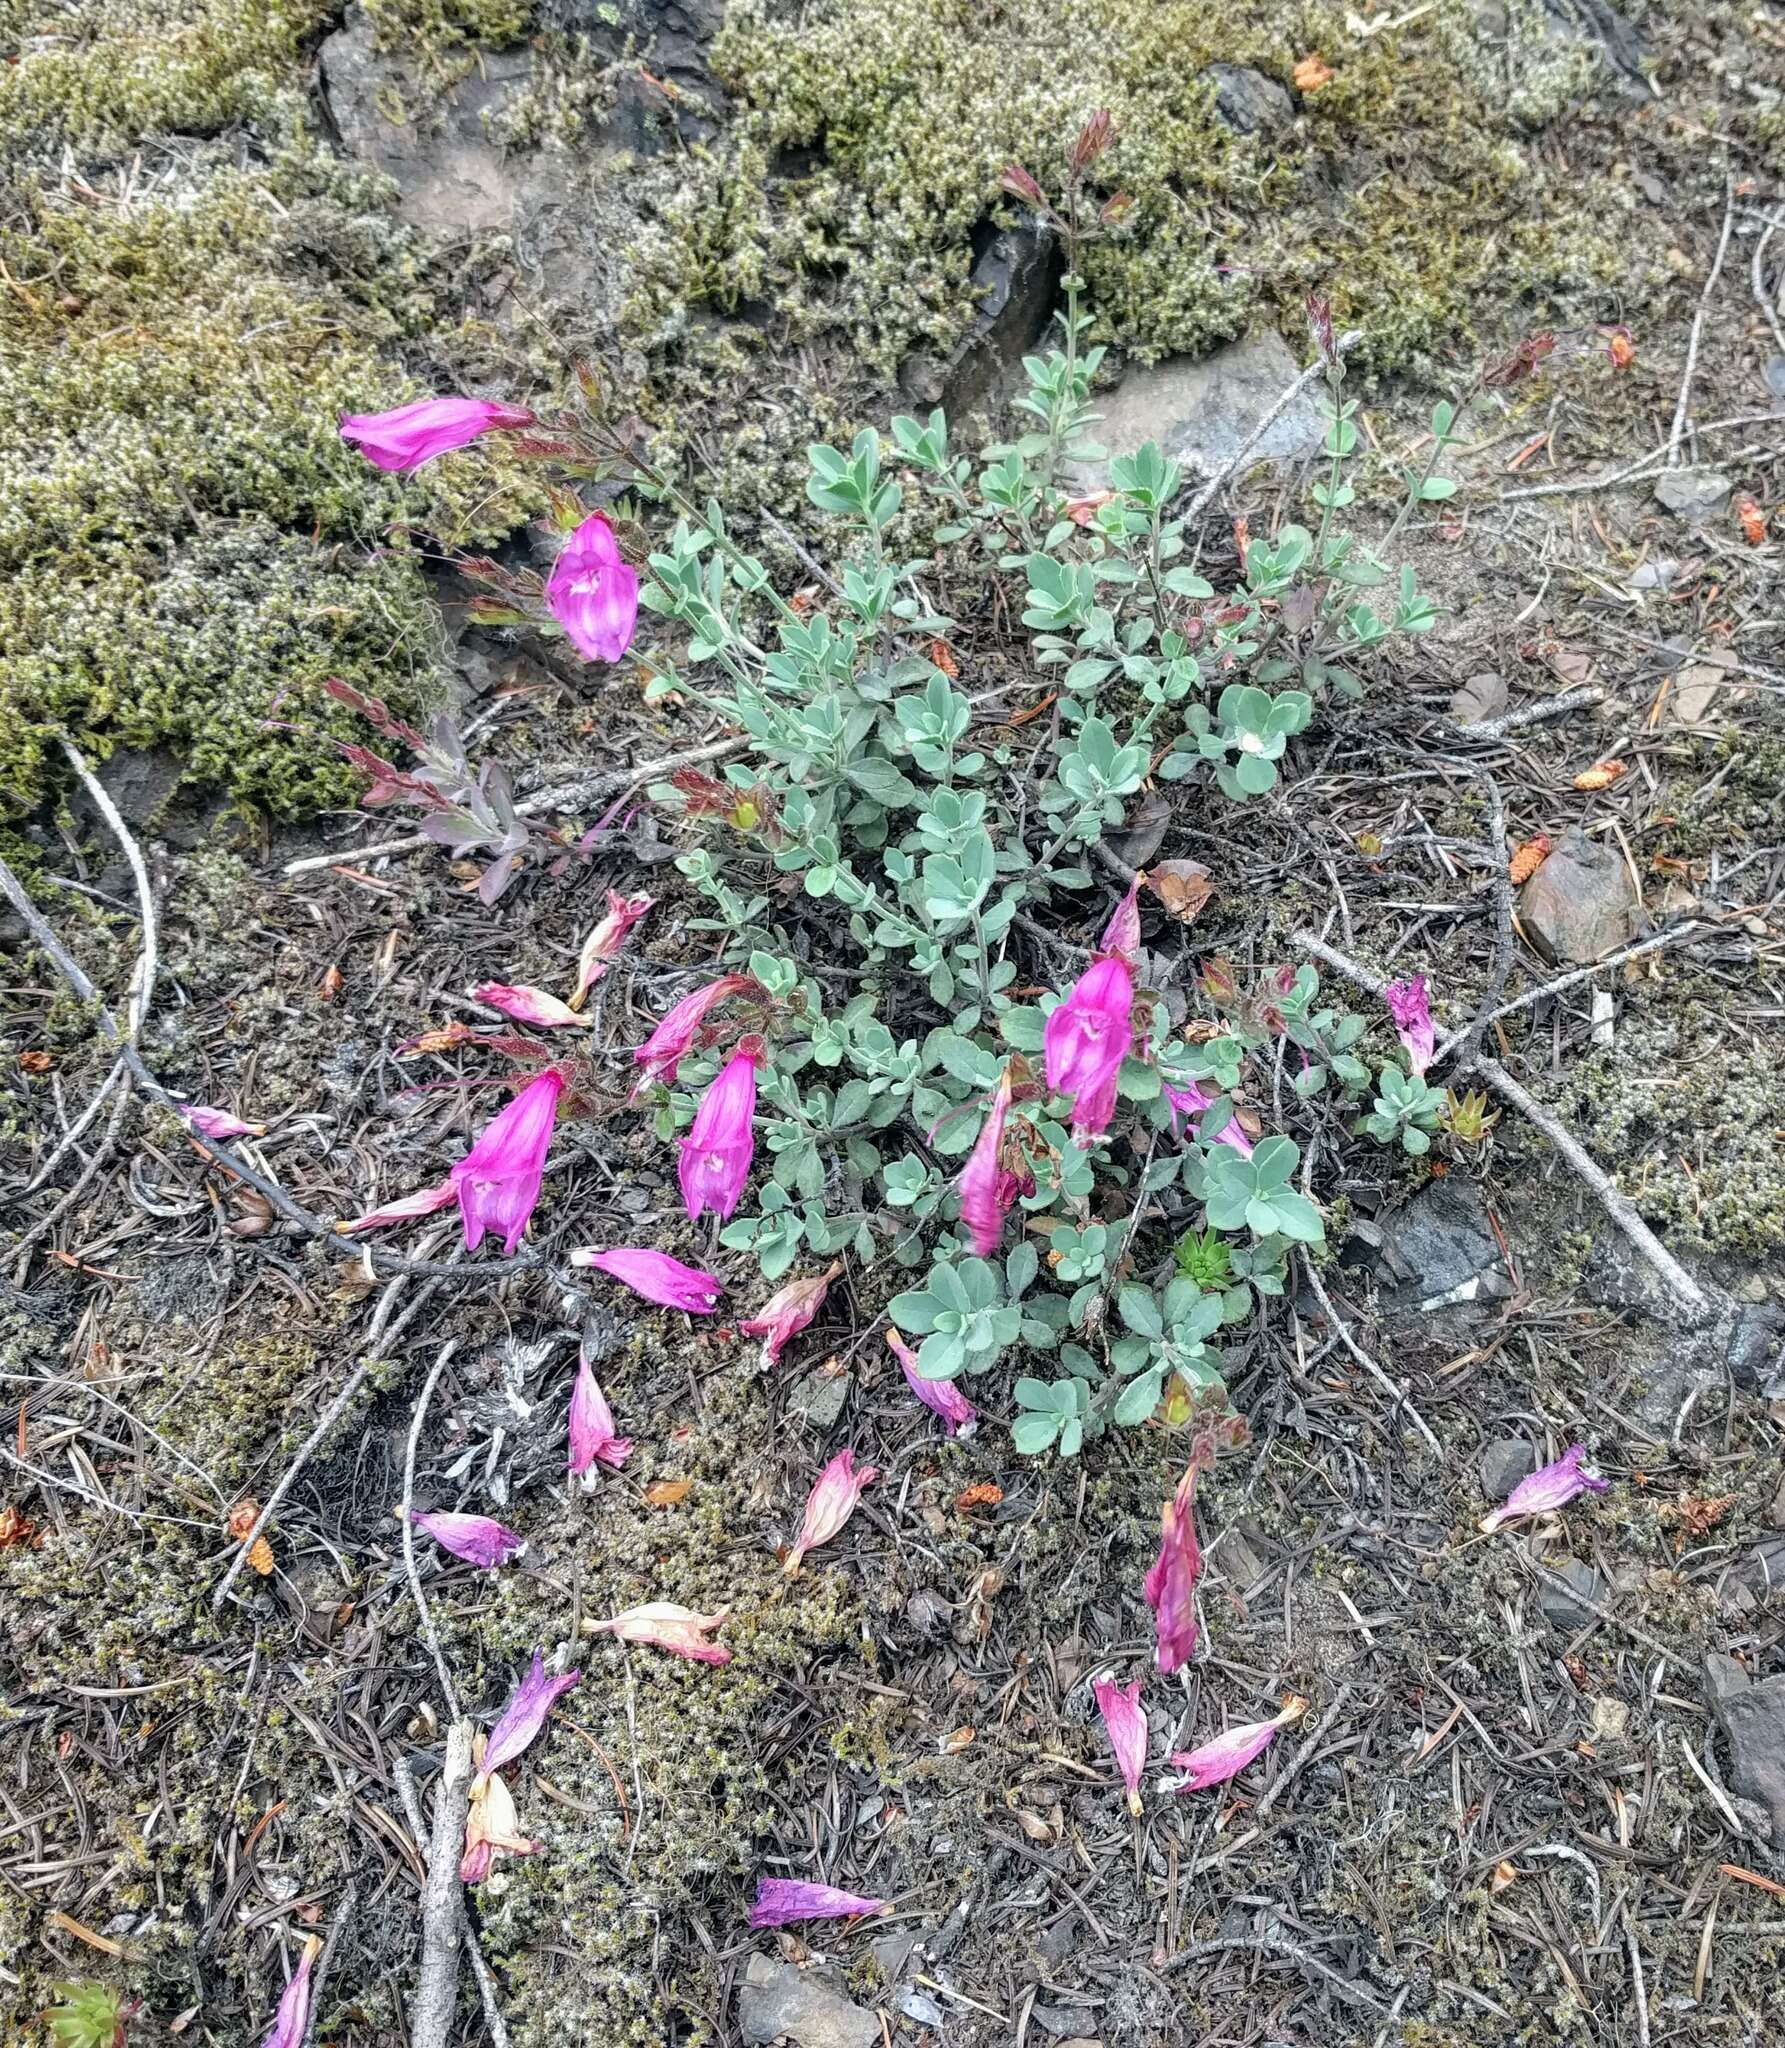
[1077, 330, 1326, 489]
